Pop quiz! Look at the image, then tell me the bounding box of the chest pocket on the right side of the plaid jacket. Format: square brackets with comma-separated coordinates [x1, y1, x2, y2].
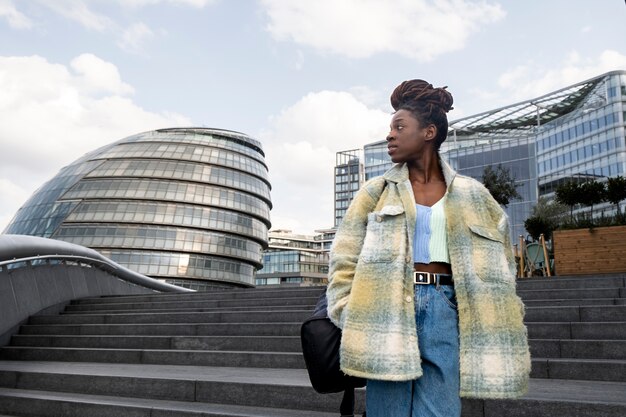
[469, 224, 509, 282]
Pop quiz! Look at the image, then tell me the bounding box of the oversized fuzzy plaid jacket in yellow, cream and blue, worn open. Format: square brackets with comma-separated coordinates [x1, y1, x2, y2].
[327, 161, 530, 398]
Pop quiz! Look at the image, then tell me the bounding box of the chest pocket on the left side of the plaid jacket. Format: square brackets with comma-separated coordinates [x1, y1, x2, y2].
[360, 206, 406, 262]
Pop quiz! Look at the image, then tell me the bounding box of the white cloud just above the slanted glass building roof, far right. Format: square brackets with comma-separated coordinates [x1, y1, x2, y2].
[498, 50, 626, 100]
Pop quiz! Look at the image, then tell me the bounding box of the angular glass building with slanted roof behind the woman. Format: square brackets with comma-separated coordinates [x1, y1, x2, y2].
[342, 71, 626, 240]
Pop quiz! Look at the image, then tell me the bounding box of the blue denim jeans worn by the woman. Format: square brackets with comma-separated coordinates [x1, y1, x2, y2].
[366, 285, 461, 417]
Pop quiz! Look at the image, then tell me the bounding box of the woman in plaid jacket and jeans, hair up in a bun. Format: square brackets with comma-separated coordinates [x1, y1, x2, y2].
[327, 80, 530, 417]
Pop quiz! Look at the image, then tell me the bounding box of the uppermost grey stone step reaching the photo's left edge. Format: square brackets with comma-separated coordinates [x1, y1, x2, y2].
[0, 346, 305, 369]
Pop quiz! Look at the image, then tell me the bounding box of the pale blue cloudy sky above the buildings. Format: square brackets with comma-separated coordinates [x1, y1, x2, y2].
[0, 0, 626, 233]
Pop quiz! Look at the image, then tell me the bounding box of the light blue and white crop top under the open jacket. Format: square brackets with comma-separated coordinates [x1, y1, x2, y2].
[413, 195, 450, 264]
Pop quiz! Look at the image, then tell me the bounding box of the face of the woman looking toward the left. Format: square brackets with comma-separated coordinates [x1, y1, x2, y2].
[387, 109, 437, 163]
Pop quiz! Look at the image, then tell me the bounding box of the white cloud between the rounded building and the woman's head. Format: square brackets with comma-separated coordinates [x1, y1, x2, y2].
[260, 91, 390, 233]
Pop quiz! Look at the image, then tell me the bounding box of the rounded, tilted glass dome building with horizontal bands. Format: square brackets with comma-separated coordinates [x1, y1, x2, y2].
[4, 128, 272, 290]
